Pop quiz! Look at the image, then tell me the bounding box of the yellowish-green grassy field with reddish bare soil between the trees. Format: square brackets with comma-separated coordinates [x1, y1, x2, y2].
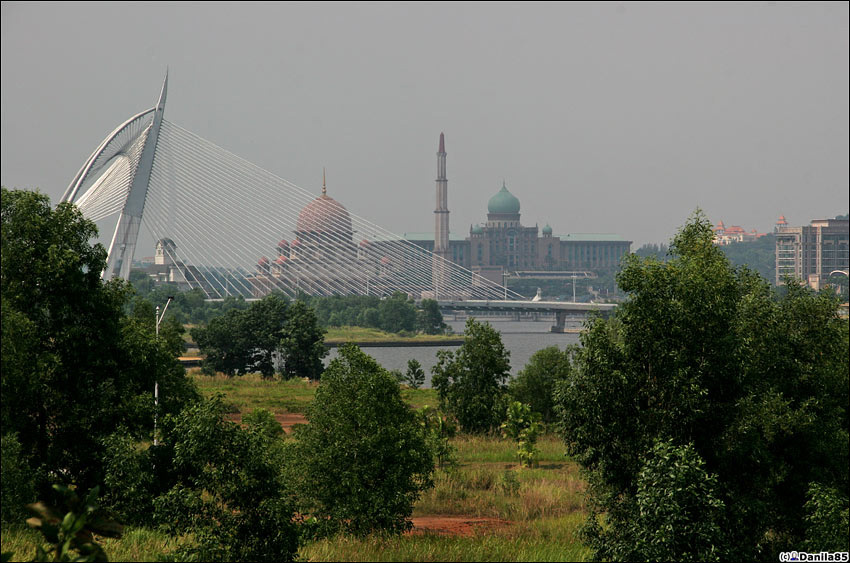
[2, 371, 590, 561]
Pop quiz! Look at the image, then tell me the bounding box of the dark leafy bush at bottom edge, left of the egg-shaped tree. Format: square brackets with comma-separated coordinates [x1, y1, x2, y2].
[152, 399, 298, 561]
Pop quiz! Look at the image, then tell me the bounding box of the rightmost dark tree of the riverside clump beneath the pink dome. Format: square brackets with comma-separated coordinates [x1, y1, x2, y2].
[280, 300, 328, 380]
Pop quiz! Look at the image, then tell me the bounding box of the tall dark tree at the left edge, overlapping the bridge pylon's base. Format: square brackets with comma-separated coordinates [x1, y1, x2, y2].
[0, 188, 197, 496]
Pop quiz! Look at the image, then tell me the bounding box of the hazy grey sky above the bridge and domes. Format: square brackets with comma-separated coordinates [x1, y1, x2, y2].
[0, 2, 850, 249]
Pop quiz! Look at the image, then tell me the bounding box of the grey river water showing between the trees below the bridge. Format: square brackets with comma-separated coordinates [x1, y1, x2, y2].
[325, 320, 578, 387]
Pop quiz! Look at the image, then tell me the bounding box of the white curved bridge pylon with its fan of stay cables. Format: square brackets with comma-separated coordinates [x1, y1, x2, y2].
[62, 75, 522, 300]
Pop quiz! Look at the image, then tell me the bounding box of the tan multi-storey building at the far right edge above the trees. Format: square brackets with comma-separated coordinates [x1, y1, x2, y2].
[776, 217, 850, 289]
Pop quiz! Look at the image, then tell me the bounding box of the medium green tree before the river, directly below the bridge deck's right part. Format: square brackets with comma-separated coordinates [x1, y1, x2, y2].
[431, 318, 511, 432]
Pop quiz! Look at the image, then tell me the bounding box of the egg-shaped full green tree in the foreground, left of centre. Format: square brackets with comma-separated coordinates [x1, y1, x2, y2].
[289, 344, 434, 535]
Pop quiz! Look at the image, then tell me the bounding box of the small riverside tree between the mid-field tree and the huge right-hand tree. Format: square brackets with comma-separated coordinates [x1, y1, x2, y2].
[508, 346, 573, 424]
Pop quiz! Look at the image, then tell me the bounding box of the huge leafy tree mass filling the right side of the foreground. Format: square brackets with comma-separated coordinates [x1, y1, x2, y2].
[556, 212, 850, 559]
